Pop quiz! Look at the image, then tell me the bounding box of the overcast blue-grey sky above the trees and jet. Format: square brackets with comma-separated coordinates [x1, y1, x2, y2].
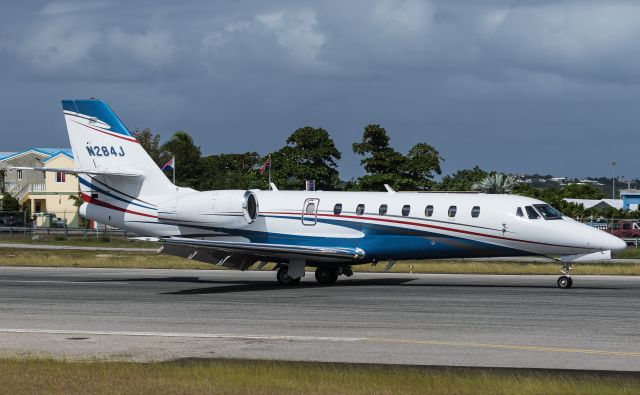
[0, 0, 640, 179]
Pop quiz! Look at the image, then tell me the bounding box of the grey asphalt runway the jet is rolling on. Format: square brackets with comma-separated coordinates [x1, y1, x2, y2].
[0, 267, 640, 371]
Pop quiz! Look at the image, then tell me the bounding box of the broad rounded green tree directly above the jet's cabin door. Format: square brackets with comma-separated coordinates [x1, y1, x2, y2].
[271, 126, 341, 190]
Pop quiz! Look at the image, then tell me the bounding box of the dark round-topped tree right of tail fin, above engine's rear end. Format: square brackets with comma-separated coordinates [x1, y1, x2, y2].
[161, 130, 202, 188]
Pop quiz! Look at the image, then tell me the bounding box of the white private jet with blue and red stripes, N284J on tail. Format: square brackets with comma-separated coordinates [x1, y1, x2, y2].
[13, 99, 626, 288]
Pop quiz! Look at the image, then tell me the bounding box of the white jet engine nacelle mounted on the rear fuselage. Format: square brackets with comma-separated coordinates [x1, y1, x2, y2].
[158, 190, 258, 229]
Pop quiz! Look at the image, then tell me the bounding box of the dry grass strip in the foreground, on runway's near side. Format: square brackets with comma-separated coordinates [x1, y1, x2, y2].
[0, 359, 640, 395]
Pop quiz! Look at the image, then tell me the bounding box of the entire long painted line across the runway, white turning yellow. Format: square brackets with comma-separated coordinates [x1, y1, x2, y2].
[0, 328, 640, 358]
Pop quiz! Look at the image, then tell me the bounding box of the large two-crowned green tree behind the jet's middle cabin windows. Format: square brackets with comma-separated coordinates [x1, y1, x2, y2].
[352, 124, 442, 191]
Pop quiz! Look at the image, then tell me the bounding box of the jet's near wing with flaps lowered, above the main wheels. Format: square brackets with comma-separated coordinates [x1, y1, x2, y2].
[159, 237, 365, 270]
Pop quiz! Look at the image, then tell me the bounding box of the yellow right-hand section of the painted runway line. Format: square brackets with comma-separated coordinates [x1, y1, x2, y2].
[363, 338, 640, 358]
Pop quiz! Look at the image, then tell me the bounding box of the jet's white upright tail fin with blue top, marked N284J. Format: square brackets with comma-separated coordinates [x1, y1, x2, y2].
[62, 99, 175, 197]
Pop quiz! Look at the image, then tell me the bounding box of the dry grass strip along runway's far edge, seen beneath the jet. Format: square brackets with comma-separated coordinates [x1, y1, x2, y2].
[0, 248, 640, 275]
